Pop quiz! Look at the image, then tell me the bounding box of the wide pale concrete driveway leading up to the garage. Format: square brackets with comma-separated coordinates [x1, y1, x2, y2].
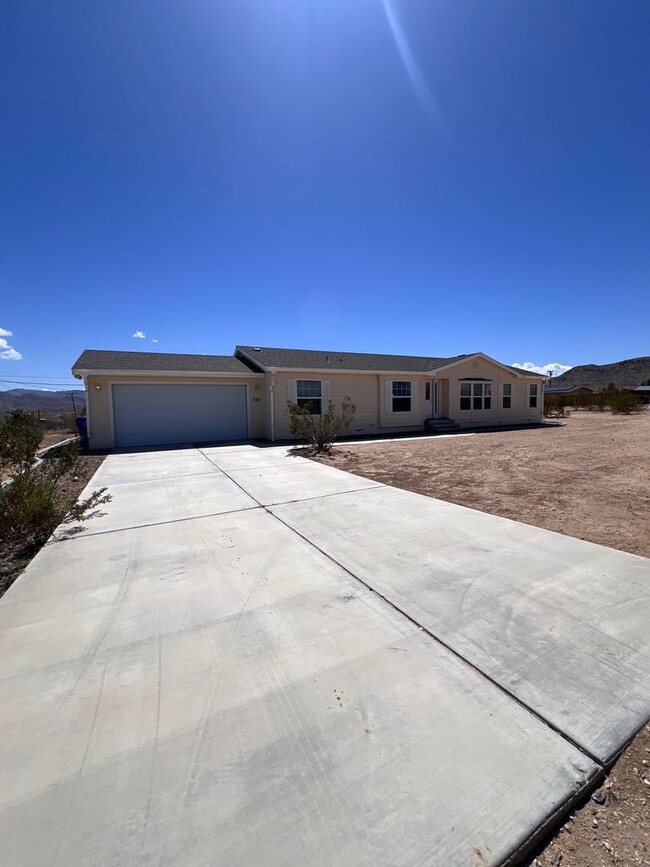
[0, 446, 650, 867]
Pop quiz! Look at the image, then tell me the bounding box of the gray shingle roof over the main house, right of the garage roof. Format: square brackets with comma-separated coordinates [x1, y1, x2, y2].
[235, 346, 465, 373]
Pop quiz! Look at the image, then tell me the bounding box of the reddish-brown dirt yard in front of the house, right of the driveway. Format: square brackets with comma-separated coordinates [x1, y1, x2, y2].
[316, 410, 650, 557]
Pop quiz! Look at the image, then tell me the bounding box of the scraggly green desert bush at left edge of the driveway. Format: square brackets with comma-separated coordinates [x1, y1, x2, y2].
[0, 410, 111, 548]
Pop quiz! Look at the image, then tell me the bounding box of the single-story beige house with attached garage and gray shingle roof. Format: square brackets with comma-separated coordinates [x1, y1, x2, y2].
[72, 346, 544, 449]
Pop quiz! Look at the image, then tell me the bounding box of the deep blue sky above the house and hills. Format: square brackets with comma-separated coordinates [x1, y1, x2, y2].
[0, 0, 650, 388]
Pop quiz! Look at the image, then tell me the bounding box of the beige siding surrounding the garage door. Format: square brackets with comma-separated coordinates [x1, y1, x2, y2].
[86, 374, 266, 449]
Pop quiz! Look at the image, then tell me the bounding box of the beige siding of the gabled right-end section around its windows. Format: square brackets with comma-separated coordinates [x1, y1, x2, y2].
[440, 358, 544, 427]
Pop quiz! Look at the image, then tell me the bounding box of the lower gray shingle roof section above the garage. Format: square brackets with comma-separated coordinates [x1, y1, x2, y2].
[72, 349, 256, 374]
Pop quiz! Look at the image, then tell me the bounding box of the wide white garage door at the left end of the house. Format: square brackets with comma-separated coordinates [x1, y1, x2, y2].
[113, 385, 246, 446]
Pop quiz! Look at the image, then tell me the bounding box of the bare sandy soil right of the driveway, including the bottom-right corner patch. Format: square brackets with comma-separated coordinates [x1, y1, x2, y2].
[312, 410, 650, 867]
